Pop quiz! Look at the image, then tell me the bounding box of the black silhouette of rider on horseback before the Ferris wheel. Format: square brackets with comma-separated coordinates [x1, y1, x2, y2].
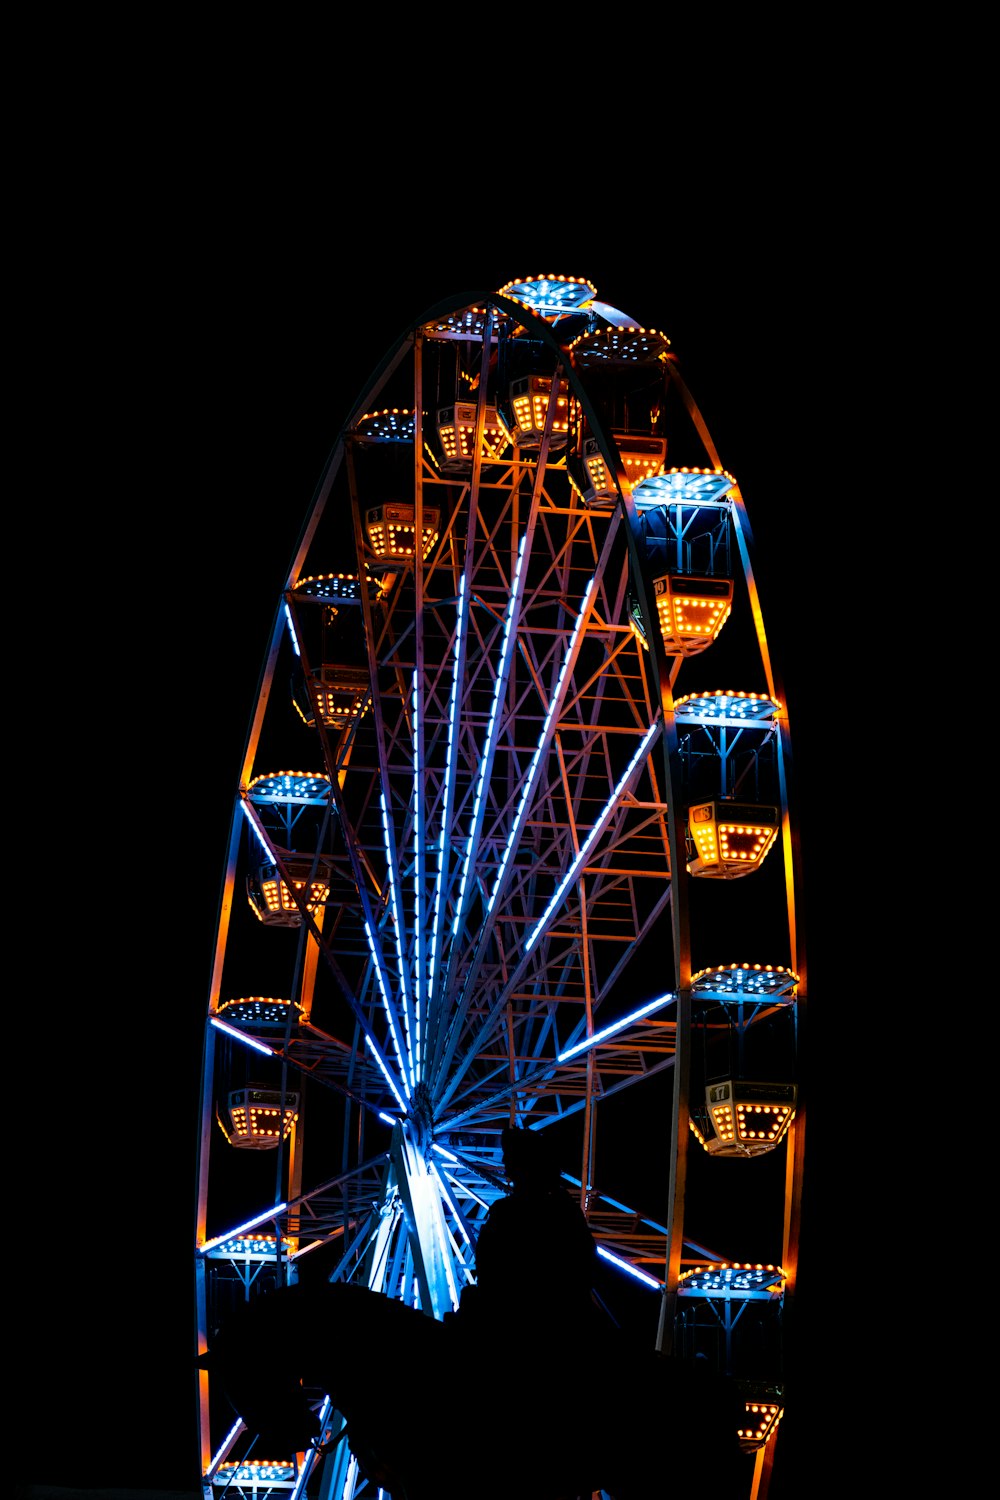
[205, 1131, 751, 1500]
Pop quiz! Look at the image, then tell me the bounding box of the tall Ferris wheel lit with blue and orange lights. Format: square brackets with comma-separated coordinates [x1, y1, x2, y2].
[195, 275, 805, 1500]
